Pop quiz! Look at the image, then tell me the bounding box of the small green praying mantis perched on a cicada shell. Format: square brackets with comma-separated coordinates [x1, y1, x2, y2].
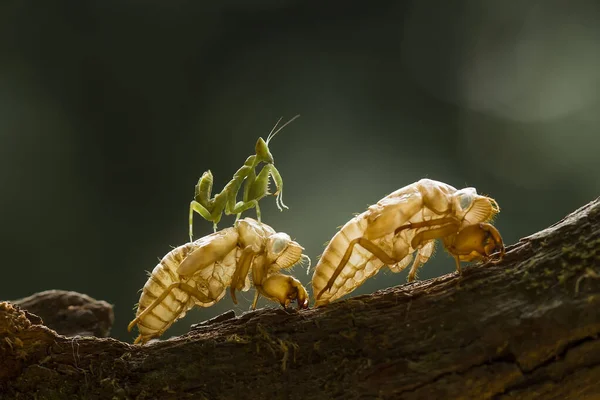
[189, 115, 300, 242]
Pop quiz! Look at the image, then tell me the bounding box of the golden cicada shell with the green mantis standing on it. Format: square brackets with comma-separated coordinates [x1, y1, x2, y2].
[128, 218, 310, 343]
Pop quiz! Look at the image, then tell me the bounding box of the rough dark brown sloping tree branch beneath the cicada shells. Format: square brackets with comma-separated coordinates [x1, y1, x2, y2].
[0, 199, 600, 399]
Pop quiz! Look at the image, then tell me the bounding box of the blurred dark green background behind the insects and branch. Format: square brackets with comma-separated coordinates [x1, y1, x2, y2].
[0, 0, 600, 340]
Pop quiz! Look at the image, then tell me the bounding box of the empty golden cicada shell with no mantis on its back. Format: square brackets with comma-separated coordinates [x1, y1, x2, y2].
[312, 179, 504, 306]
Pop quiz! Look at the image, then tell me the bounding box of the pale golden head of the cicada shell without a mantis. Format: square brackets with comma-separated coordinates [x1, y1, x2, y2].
[452, 188, 500, 227]
